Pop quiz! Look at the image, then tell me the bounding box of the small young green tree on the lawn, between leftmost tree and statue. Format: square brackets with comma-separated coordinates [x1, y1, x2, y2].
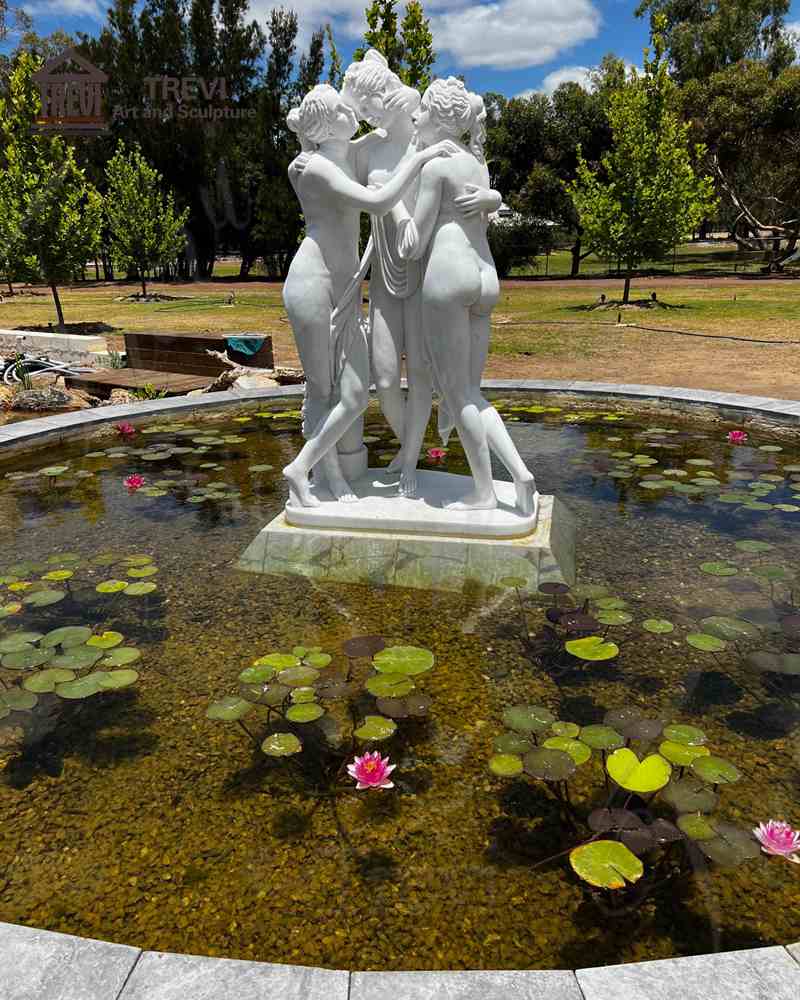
[105, 142, 189, 296]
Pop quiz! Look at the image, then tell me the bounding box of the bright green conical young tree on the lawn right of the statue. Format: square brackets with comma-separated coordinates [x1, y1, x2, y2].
[567, 19, 716, 305]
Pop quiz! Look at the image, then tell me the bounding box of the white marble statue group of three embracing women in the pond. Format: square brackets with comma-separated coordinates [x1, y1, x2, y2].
[283, 50, 539, 520]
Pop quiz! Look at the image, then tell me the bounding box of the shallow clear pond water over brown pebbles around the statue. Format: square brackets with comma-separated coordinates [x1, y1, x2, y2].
[0, 395, 800, 969]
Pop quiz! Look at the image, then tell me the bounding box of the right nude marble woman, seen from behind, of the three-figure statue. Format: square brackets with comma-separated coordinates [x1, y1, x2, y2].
[398, 77, 539, 515]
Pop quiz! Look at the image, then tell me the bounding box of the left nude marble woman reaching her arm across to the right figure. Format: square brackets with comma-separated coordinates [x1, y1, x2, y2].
[283, 84, 457, 507]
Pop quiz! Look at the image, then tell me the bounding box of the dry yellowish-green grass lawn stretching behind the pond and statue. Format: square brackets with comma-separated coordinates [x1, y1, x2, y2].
[0, 274, 800, 399]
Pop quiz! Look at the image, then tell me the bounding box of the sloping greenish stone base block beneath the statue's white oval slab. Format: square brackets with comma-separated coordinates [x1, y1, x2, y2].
[237, 496, 575, 591]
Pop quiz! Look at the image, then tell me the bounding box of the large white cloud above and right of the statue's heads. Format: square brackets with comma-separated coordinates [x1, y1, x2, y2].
[429, 0, 601, 69]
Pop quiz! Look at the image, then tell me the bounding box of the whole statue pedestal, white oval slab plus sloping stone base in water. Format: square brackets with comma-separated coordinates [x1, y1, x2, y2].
[237, 471, 575, 591]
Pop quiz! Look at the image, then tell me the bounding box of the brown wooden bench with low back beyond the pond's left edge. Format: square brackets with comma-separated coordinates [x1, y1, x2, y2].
[66, 333, 275, 399]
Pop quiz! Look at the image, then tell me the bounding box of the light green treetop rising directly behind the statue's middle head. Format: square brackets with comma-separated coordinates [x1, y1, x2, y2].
[353, 0, 436, 90]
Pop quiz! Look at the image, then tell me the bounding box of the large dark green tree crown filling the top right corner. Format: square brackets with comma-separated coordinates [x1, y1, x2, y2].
[636, 0, 795, 83]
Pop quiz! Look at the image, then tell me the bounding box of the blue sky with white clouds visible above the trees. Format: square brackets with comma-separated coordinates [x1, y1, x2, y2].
[4, 0, 800, 97]
